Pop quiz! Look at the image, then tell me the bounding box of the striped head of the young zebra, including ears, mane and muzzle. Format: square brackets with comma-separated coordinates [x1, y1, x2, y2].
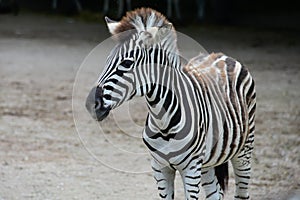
[86, 8, 177, 121]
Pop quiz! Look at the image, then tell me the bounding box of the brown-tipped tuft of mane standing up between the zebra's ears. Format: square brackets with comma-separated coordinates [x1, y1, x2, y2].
[114, 8, 170, 34]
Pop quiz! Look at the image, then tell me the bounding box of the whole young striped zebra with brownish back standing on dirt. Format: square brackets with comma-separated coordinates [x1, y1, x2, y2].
[86, 8, 256, 199]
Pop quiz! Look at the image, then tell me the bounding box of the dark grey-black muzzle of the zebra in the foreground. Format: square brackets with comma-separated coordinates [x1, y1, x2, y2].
[85, 87, 110, 121]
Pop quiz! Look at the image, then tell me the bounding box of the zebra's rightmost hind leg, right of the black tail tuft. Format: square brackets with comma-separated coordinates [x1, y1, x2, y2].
[231, 134, 253, 199]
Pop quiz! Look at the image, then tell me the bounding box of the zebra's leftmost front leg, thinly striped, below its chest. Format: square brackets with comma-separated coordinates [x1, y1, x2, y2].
[152, 161, 175, 200]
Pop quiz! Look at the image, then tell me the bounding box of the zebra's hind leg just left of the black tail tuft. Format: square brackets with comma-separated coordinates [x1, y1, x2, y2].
[201, 168, 224, 200]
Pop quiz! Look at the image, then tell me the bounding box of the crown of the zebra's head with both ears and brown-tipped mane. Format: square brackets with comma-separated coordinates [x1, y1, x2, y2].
[105, 8, 181, 67]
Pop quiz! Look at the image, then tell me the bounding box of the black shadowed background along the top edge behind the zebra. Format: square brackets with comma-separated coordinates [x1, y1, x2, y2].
[0, 0, 300, 30]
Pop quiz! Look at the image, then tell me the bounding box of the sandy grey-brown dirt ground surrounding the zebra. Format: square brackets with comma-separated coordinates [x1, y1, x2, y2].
[0, 14, 300, 200]
